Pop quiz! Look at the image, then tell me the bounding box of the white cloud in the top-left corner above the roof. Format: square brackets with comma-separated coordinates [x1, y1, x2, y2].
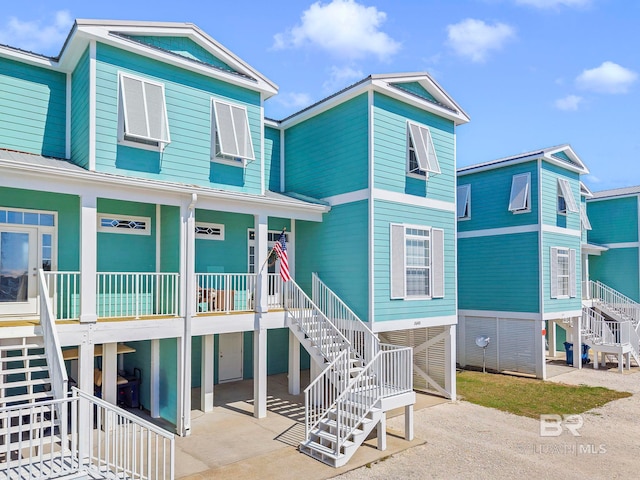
[0, 10, 73, 54]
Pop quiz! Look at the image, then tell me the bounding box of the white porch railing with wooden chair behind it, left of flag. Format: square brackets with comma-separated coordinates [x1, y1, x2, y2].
[195, 273, 257, 313]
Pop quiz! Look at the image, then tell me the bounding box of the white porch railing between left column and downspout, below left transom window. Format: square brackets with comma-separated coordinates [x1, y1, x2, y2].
[96, 272, 180, 318]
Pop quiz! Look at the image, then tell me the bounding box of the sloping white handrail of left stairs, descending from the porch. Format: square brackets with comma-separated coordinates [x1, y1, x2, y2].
[38, 269, 68, 399]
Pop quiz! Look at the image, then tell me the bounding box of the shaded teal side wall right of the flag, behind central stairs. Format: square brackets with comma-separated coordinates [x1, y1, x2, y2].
[296, 200, 369, 321]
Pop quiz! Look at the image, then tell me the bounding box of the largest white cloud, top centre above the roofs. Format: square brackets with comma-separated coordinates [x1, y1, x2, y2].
[273, 0, 400, 59]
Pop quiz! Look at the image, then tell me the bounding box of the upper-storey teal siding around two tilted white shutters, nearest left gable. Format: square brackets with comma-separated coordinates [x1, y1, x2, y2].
[96, 44, 262, 193]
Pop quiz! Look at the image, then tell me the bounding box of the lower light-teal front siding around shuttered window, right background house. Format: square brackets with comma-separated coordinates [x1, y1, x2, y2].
[542, 232, 593, 313]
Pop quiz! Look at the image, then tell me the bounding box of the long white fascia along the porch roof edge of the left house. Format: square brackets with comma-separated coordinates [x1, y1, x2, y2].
[0, 160, 331, 222]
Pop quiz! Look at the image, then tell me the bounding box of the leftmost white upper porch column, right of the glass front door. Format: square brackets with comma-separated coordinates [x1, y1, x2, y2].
[80, 195, 98, 323]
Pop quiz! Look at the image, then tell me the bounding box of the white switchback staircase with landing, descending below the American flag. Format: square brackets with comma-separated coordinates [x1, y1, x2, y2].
[285, 276, 415, 467]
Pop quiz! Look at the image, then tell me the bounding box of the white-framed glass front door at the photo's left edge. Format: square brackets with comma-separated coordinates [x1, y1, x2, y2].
[0, 226, 38, 315]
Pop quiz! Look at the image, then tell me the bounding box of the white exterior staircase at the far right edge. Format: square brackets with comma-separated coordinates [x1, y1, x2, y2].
[581, 281, 640, 371]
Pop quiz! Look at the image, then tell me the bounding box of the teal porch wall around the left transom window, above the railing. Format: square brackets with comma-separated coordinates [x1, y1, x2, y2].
[98, 198, 156, 272]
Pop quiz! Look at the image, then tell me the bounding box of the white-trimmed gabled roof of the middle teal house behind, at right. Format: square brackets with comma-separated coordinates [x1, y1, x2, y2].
[458, 144, 589, 176]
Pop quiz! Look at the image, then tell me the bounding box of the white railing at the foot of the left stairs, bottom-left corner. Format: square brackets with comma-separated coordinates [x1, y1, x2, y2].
[0, 388, 175, 480]
